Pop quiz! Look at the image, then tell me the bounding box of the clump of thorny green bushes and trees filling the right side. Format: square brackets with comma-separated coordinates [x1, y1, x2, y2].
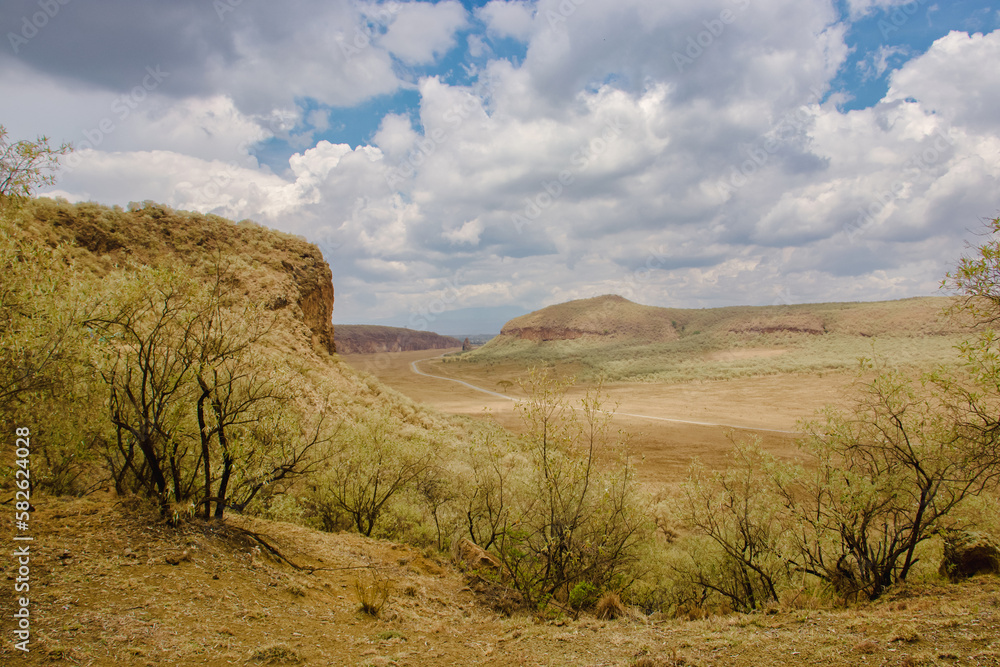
[660, 219, 1000, 611]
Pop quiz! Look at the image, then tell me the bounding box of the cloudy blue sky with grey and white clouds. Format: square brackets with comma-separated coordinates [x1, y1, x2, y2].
[0, 0, 1000, 334]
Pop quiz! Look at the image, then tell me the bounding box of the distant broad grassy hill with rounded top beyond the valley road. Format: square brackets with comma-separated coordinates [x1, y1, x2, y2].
[448, 295, 968, 382]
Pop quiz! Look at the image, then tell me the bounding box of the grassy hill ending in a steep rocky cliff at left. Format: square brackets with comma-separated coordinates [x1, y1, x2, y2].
[0, 198, 468, 500]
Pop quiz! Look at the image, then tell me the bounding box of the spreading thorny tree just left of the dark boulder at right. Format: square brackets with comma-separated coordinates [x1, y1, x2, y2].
[781, 362, 1000, 599]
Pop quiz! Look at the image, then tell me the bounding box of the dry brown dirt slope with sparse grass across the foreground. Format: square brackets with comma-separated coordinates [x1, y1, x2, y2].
[0, 498, 1000, 667]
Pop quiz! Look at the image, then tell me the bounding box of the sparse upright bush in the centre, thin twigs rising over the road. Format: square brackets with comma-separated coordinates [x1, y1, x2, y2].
[484, 372, 649, 605]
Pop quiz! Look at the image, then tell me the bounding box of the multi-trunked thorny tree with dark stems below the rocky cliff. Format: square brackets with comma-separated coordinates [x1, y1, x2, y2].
[88, 267, 326, 519]
